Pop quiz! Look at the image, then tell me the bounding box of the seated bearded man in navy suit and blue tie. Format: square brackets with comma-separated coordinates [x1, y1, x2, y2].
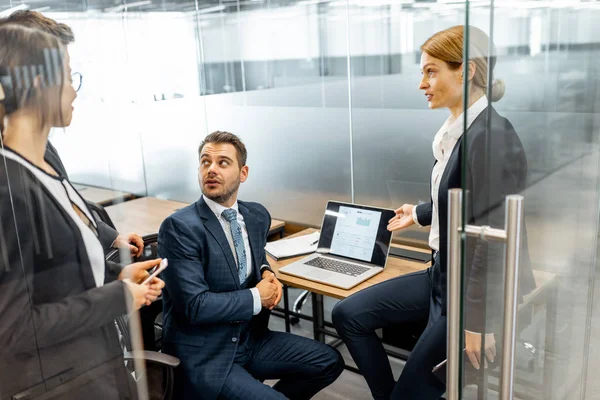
[158, 132, 344, 400]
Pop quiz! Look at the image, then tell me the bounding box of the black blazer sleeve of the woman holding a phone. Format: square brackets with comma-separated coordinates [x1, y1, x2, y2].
[0, 180, 126, 357]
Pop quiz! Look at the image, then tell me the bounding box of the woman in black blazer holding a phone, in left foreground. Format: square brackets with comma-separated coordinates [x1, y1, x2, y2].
[0, 24, 164, 400]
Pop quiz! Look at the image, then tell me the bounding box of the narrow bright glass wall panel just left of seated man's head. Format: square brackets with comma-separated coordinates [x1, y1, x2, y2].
[128, 9, 206, 202]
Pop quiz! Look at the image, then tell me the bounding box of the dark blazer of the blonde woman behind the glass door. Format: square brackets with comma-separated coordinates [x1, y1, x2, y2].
[417, 108, 535, 332]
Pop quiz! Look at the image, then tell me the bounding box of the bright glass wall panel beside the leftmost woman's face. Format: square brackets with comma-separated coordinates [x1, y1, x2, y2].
[45, 7, 151, 195]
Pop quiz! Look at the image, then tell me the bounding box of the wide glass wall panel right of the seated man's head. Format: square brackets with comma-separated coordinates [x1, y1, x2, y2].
[198, 1, 350, 225]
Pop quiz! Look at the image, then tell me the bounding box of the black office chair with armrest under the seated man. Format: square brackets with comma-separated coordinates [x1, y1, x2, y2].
[106, 234, 180, 400]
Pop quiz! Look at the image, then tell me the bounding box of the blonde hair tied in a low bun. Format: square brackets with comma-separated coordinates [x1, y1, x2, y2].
[421, 25, 505, 101]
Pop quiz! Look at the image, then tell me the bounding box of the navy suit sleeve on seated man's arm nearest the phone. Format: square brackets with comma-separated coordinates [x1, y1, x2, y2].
[158, 216, 254, 325]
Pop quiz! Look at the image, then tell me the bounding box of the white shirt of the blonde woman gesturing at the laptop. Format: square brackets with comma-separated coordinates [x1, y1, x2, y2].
[413, 96, 488, 251]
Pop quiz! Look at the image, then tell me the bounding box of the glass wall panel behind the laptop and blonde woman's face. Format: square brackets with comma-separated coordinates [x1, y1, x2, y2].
[349, 2, 464, 245]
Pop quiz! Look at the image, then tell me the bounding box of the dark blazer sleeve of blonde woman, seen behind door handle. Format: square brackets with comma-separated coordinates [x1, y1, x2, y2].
[466, 130, 527, 332]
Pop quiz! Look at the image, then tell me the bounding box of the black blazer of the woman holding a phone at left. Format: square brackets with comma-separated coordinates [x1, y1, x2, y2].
[0, 155, 135, 400]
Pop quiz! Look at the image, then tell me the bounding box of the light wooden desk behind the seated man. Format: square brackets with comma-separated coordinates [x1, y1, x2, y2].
[106, 197, 285, 236]
